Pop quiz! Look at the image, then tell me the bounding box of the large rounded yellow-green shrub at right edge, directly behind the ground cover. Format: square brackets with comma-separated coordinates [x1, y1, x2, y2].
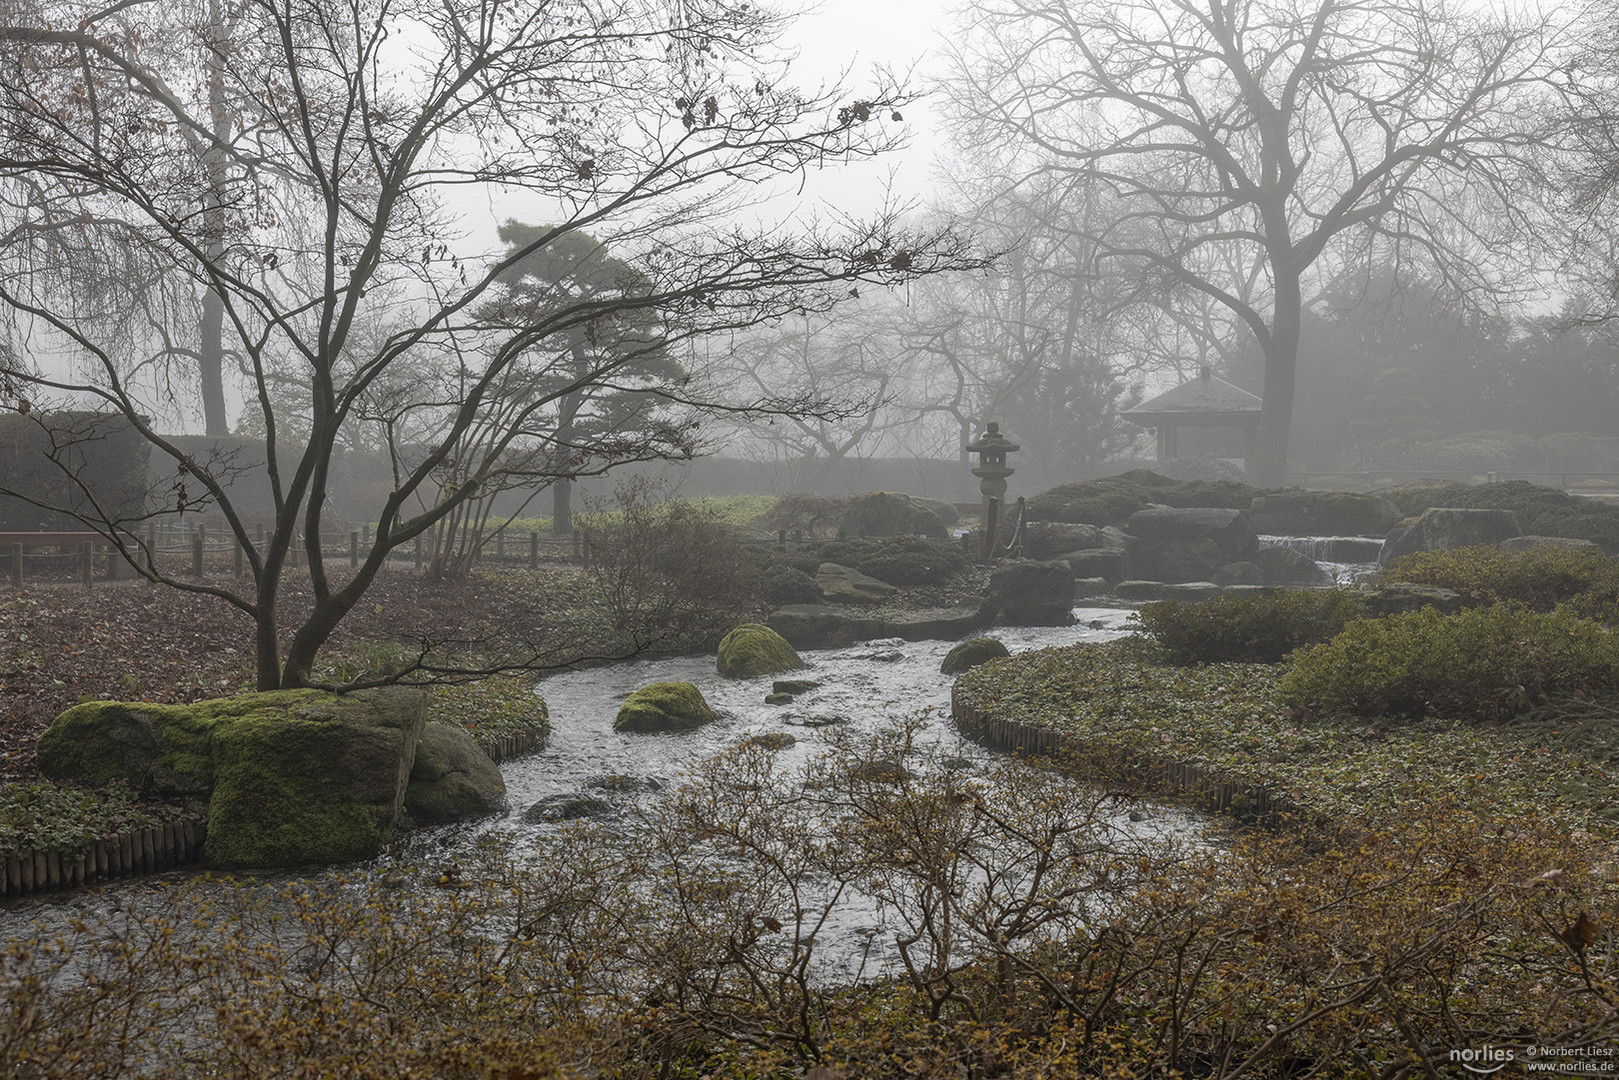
[1277, 604, 1619, 721]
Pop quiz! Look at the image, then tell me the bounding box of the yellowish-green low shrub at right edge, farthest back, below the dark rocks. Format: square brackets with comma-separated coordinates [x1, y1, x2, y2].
[1376, 546, 1619, 622]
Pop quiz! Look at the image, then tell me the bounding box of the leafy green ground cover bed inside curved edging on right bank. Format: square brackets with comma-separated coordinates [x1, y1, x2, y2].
[955, 640, 1619, 826]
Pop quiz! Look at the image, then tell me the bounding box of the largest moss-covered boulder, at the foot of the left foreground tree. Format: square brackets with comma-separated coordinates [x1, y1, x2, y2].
[39, 688, 426, 868]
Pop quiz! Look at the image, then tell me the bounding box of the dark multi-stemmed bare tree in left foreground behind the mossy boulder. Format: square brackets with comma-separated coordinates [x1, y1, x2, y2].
[0, 0, 970, 688]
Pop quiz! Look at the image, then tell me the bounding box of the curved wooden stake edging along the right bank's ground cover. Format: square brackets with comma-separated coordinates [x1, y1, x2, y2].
[950, 687, 1298, 821]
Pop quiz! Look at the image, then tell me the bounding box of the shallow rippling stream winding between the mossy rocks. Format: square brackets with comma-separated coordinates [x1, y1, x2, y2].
[0, 552, 1365, 980]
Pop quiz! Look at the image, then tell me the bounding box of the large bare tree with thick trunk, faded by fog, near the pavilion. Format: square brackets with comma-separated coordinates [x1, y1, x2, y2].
[952, 0, 1566, 483]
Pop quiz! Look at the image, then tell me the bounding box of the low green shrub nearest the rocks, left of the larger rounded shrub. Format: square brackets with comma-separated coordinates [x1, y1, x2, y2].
[1137, 589, 1366, 665]
